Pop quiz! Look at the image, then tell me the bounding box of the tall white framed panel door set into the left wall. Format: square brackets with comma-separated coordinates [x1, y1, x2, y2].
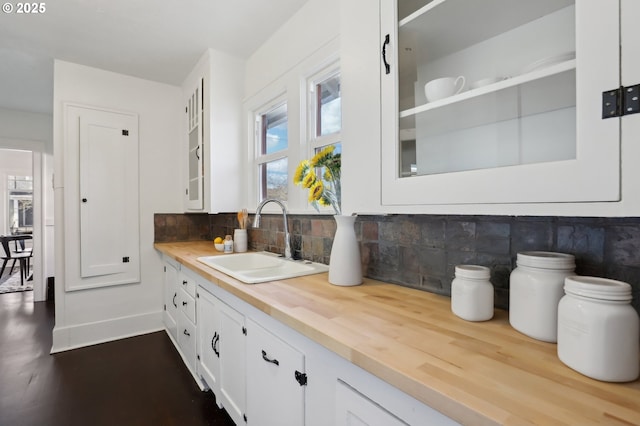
[64, 105, 140, 290]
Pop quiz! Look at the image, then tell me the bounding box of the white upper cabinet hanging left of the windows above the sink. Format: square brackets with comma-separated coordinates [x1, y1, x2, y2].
[182, 49, 245, 213]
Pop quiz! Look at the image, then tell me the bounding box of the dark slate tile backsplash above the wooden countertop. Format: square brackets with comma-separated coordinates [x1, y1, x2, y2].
[155, 213, 640, 312]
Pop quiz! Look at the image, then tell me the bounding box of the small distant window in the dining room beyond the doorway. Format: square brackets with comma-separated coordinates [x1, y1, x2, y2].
[7, 176, 33, 234]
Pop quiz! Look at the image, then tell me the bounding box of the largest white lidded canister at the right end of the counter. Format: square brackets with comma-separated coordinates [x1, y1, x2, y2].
[558, 276, 640, 382]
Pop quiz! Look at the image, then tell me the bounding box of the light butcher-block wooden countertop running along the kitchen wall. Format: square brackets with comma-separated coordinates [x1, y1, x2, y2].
[155, 241, 640, 425]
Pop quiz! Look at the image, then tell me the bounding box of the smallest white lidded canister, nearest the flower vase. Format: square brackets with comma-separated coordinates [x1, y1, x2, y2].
[451, 265, 493, 321]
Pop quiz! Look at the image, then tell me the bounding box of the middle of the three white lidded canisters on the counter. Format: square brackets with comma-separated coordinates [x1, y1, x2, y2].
[509, 251, 576, 342]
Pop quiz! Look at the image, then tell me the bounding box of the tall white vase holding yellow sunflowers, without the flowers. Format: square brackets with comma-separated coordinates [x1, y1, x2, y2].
[329, 215, 362, 286]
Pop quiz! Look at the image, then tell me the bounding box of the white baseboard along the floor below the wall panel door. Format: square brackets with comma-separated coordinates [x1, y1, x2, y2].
[51, 311, 164, 354]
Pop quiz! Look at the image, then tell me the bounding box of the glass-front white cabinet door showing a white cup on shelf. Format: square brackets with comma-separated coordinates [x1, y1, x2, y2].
[381, 0, 620, 205]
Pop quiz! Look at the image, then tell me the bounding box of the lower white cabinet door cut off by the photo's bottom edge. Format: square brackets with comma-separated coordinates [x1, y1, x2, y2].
[336, 381, 407, 426]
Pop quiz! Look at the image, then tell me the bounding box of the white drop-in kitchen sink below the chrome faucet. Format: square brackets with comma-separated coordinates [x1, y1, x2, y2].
[198, 252, 329, 284]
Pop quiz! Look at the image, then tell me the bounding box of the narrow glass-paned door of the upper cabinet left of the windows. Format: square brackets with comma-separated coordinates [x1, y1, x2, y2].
[185, 79, 204, 210]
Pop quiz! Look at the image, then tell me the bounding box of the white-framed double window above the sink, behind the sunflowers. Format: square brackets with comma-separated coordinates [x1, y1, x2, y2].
[248, 53, 342, 213]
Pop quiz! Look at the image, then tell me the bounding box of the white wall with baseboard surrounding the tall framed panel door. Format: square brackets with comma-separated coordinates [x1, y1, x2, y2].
[52, 60, 183, 352]
